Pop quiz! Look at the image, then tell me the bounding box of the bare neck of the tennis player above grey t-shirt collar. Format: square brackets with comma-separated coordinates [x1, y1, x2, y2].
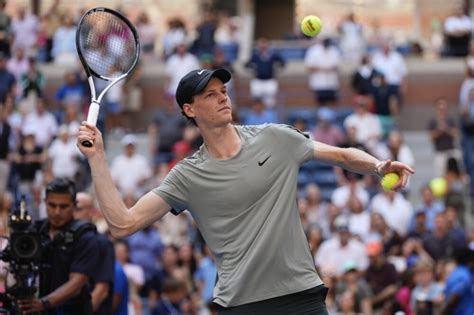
[201, 124, 241, 160]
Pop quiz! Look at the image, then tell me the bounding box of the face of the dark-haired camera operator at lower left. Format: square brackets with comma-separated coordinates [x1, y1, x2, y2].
[44, 193, 74, 229]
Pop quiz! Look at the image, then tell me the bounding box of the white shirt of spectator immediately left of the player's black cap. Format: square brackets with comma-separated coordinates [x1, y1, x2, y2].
[165, 53, 201, 95]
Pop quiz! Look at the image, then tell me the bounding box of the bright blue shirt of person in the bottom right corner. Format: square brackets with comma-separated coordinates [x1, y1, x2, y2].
[444, 265, 474, 315]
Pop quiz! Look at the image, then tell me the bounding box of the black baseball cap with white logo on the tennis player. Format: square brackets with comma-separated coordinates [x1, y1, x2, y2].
[176, 69, 232, 108]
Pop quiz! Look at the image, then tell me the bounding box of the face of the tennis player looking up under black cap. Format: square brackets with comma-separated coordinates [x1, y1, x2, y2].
[185, 78, 232, 127]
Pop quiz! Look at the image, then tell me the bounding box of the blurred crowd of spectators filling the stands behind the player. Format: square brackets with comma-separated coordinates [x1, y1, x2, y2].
[0, 1, 474, 315]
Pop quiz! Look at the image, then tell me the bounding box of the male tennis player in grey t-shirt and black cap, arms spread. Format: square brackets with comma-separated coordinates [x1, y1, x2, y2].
[78, 69, 414, 314]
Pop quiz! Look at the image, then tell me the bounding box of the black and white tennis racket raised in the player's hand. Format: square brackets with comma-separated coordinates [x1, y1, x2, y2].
[76, 7, 140, 147]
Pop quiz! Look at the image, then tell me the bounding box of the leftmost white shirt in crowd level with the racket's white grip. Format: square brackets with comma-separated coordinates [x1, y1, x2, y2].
[22, 111, 58, 147]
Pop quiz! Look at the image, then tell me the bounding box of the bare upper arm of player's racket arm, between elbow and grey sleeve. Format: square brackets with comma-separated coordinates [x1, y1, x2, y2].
[129, 191, 171, 230]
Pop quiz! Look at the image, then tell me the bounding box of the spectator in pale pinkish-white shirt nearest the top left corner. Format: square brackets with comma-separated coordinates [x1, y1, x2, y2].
[11, 6, 39, 54]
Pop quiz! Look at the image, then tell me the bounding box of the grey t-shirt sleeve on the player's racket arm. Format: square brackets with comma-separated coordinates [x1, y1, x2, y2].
[153, 163, 188, 215]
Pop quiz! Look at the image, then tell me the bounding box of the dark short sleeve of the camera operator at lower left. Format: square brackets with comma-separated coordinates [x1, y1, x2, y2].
[70, 232, 100, 277]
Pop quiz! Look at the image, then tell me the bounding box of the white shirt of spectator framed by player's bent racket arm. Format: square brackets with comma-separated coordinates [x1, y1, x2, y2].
[110, 154, 152, 194]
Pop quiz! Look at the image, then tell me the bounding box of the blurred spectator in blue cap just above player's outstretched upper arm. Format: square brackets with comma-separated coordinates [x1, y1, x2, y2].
[312, 107, 345, 146]
